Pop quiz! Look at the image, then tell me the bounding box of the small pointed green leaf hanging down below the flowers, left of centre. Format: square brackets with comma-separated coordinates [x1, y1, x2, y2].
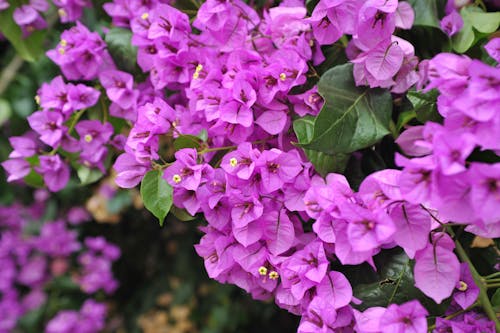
[141, 170, 172, 226]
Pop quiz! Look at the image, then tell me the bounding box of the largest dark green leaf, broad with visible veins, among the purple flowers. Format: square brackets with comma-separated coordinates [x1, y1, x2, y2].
[301, 64, 392, 154]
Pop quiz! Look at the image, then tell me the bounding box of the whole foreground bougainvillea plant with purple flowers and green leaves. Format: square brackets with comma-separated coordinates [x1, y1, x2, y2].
[0, 0, 500, 333]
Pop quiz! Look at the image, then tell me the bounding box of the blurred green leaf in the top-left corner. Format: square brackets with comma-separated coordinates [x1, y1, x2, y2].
[0, 5, 46, 61]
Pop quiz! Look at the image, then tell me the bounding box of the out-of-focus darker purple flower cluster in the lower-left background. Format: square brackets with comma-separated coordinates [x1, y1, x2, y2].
[0, 198, 120, 333]
